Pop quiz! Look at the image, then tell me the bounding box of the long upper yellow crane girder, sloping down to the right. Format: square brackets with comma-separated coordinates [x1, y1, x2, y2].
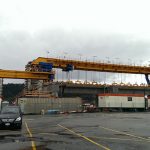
[31, 57, 150, 85]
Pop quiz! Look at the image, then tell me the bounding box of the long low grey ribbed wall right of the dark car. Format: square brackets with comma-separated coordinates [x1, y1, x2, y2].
[18, 97, 82, 114]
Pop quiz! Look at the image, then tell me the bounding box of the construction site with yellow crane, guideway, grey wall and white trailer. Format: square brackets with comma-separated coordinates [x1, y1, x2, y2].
[0, 57, 150, 114]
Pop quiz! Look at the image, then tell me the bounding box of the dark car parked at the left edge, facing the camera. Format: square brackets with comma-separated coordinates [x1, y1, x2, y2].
[0, 106, 22, 129]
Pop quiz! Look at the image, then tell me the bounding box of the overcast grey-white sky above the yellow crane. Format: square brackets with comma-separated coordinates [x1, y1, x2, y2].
[0, 0, 150, 83]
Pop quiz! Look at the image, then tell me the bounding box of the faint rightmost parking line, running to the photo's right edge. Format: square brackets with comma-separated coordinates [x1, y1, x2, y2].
[99, 126, 150, 142]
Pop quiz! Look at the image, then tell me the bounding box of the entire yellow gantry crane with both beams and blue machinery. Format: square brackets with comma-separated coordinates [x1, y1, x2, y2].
[0, 57, 150, 85]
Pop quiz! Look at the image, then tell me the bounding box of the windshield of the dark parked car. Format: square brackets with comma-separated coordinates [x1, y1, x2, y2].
[1, 107, 19, 114]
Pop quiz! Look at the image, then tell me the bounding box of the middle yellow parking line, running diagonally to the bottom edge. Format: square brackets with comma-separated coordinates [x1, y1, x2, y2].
[58, 124, 110, 150]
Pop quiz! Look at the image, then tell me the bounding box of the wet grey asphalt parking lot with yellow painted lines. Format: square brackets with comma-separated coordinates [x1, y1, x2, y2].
[0, 112, 150, 150]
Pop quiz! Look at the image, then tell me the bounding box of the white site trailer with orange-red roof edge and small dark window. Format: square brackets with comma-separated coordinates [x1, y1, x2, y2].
[98, 93, 150, 109]
